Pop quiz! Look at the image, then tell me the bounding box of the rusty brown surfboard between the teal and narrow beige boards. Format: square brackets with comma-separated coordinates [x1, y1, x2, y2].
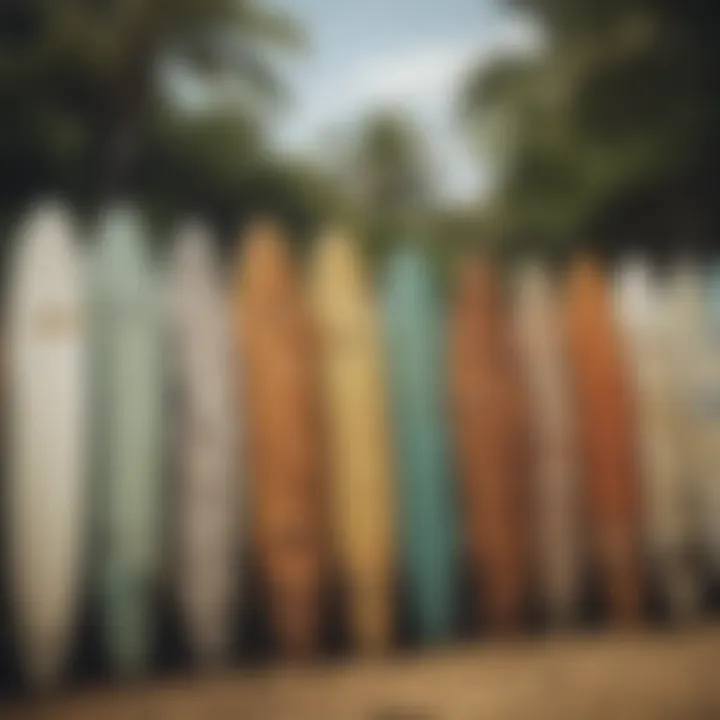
[449, 256, 529, 632]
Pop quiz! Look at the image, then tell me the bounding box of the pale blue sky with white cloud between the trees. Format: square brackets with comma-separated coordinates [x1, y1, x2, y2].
[273, 0, 535, 202]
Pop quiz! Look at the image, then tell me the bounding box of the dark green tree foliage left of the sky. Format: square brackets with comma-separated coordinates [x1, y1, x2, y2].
[0, 0, 318, 245]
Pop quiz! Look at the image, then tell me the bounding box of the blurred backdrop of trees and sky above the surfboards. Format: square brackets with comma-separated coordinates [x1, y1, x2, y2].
[0, 0, 720, 258]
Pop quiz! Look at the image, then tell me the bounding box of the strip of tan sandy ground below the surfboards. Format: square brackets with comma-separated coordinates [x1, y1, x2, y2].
[0, 626, 720, 720]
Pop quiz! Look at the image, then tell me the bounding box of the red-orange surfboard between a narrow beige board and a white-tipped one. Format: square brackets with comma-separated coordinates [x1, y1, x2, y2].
[565, 256, 642, 623]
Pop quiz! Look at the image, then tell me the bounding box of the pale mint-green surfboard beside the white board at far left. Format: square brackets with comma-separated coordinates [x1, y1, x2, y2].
[92, 207, 164, 675]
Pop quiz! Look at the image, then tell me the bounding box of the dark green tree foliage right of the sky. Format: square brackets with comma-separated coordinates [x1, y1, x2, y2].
[462, 0, 720, 253]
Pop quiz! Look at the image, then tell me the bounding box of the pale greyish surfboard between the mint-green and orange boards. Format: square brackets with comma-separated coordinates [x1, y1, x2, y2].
[168, 223, 236, 665]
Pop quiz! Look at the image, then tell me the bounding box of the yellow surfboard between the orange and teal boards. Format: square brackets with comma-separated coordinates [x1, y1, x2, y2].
[311, 231, 394, 652]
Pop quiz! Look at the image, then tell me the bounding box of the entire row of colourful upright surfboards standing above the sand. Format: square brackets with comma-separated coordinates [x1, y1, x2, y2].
[2, 201, 720, 684]
